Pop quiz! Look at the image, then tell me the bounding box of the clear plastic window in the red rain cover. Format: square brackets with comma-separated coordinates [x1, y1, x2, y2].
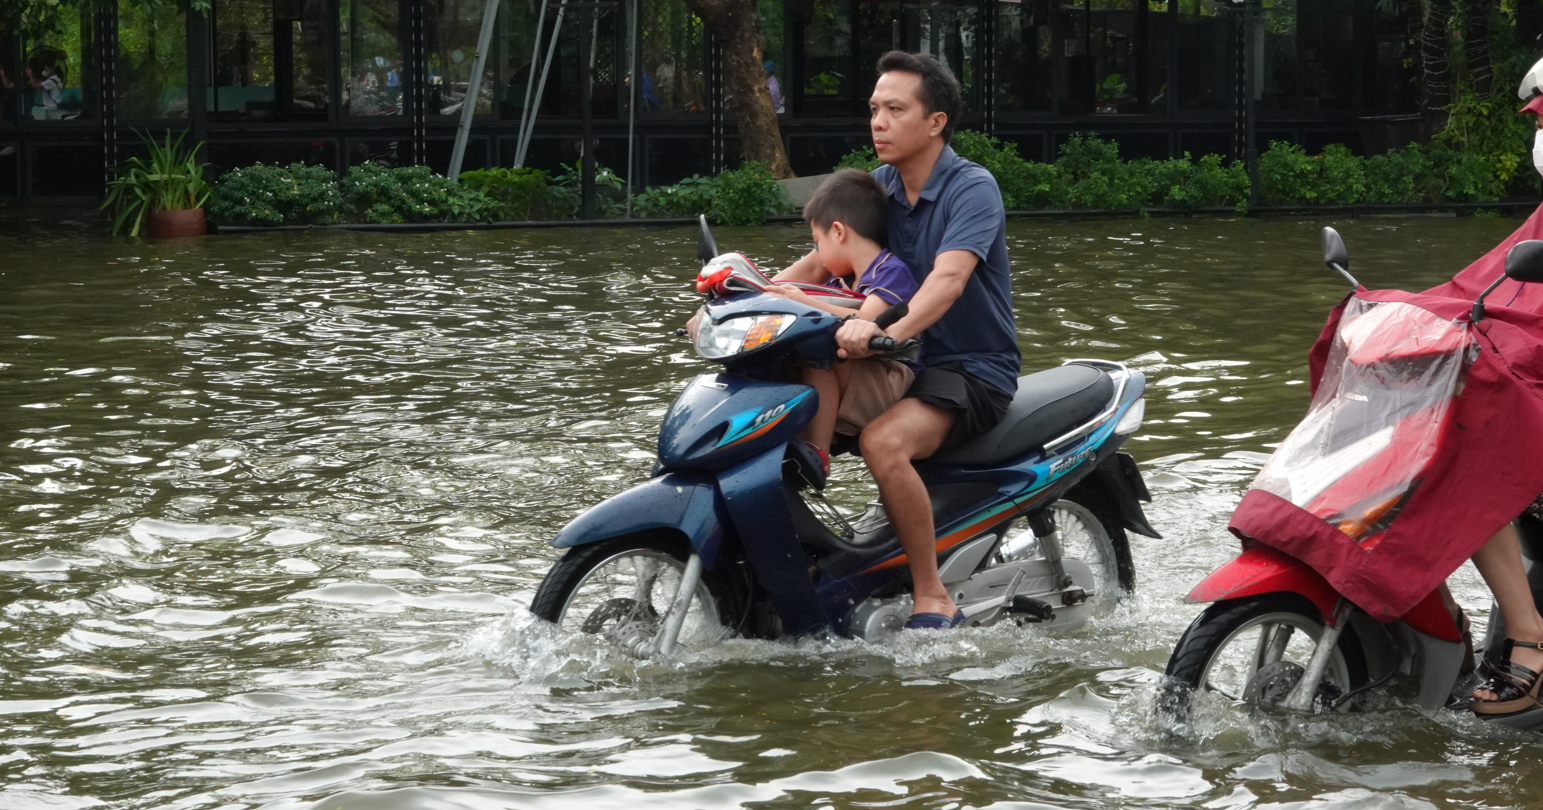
[1253, 298, 1474, 548]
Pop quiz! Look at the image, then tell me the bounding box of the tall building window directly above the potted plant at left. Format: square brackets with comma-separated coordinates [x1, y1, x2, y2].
[113, 0, 188, 122]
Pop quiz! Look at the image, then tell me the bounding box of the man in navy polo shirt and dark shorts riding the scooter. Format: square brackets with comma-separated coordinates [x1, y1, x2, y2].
[773, 51, 1021, 629]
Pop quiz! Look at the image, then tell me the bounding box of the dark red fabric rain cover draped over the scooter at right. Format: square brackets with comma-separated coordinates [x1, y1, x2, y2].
[1228, 208, 1543, 622]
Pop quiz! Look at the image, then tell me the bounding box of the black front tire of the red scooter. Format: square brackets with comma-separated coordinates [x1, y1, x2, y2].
[1157, 592, 1367, 727]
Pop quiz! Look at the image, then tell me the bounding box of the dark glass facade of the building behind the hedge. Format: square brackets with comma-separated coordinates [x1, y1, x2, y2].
[0, 0, 1413, 197]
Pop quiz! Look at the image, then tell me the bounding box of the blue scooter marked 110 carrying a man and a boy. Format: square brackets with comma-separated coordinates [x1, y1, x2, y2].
[531, 219, 1159, 657]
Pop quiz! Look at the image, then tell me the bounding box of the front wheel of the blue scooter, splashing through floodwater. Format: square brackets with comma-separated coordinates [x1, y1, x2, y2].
[531, 532, 730, 659]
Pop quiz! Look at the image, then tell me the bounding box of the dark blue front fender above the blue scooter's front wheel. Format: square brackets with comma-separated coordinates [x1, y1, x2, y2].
[552, 472, 731, 568]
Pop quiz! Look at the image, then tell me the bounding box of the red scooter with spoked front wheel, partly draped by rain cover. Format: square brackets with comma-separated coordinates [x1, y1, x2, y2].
[1159, 228, 1543, 730]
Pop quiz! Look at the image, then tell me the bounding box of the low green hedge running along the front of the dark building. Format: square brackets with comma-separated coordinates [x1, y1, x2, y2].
[208, 130, 1503, 225]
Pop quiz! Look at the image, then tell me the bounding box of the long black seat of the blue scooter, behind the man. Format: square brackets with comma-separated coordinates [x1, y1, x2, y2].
[926, 364, 1114, 467]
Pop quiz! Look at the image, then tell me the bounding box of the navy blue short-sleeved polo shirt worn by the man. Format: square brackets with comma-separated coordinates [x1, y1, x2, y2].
[873, 147, 1023, 395]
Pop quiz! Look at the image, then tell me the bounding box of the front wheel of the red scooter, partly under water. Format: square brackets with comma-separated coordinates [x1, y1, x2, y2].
[1167, 592, 1367, 702]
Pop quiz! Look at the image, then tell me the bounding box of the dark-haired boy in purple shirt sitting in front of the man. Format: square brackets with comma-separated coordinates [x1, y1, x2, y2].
[765, 168, 921, 474]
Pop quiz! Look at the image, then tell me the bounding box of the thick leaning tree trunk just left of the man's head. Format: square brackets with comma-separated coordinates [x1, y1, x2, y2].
[685, 0, 793, 179]
